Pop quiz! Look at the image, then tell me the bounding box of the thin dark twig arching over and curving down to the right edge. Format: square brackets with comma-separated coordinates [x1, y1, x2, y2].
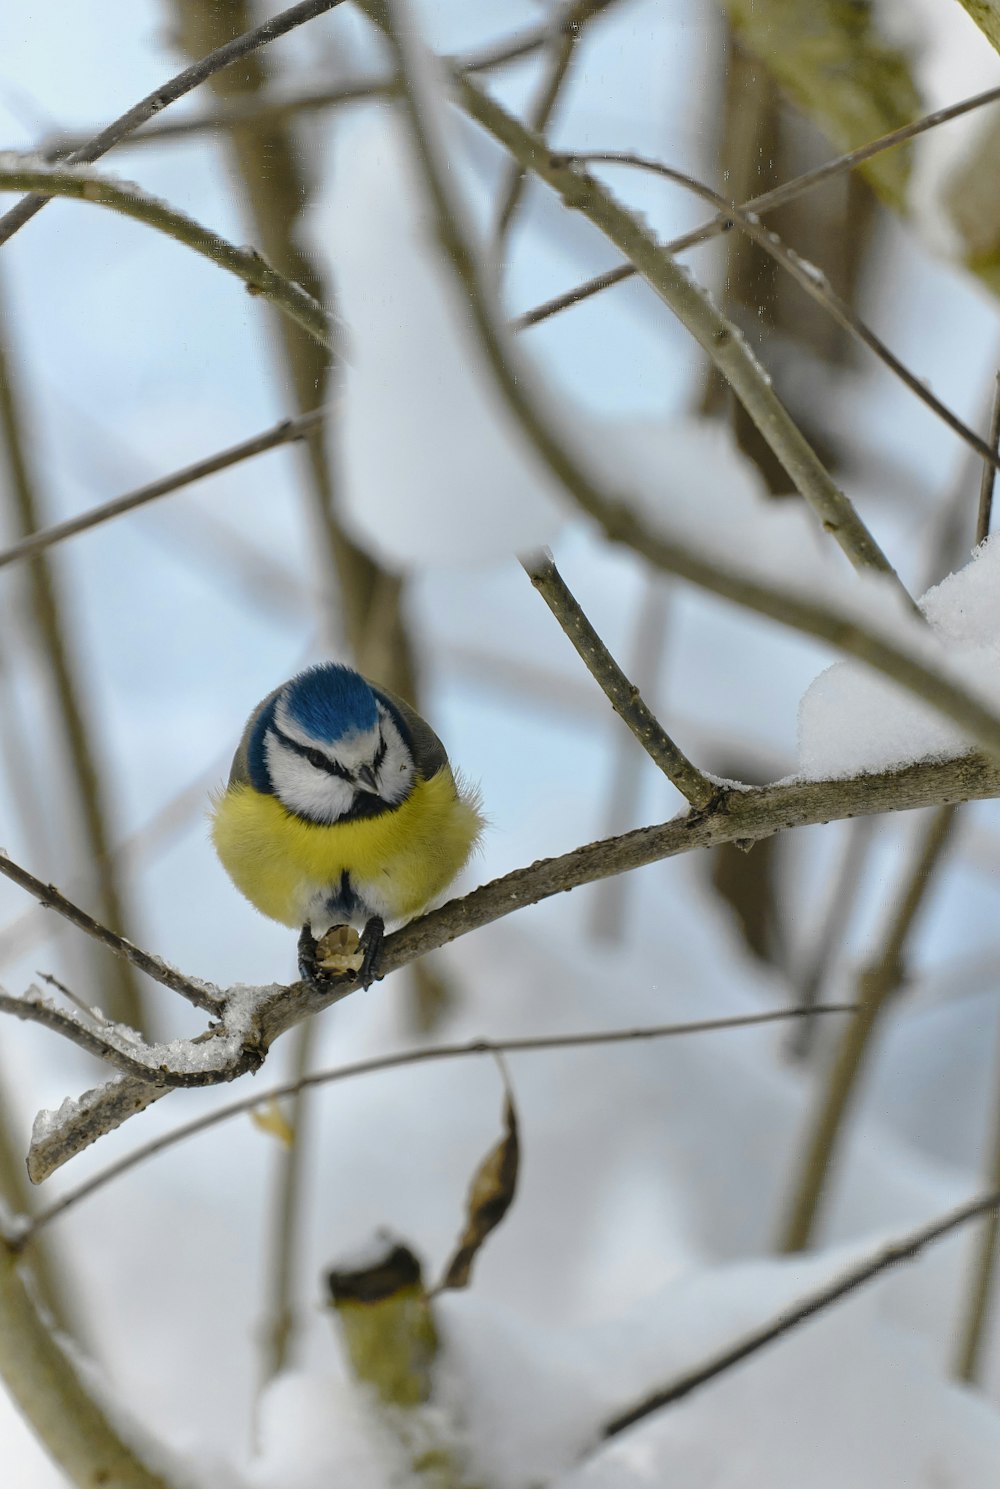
[558, 150, 1000, 471]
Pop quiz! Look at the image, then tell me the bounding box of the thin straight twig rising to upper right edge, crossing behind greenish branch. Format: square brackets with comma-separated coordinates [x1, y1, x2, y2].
[512, 88, 1000, 331]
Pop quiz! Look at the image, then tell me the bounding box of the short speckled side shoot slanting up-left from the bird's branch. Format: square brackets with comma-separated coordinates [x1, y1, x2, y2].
[521, 554, 722, 809]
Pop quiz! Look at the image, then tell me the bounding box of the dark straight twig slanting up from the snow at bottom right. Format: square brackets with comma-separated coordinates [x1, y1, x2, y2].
[600, 1190, 1000, 1441]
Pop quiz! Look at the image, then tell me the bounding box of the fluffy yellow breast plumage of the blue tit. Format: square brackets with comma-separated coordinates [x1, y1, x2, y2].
[211, 767, 482, 926]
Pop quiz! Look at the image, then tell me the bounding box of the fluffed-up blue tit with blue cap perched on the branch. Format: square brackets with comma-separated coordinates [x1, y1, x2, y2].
[211, 661, 485, 986]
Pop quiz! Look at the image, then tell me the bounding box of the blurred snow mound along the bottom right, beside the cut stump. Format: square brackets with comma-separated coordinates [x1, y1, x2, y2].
[236, 1242, 1000, 1489]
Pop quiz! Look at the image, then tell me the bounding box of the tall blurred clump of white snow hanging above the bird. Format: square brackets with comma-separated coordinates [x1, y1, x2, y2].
[311, 107, 564, 569]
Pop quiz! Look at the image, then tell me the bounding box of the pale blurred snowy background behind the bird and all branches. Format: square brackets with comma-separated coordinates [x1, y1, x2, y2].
[0, 0, 1000, 1489]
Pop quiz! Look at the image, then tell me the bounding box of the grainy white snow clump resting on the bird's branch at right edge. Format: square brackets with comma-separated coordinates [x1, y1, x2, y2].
[799, 538, 1000, 779]
